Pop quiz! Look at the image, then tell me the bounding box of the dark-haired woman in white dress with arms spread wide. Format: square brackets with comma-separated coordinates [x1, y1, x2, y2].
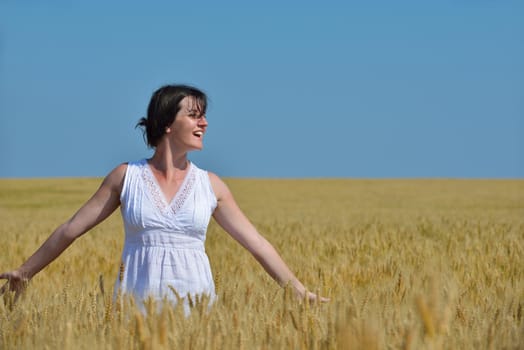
[0, 85, 327, 311]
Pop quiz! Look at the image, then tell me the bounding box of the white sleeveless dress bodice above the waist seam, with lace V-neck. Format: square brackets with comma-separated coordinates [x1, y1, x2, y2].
[120, 159, 217, 248]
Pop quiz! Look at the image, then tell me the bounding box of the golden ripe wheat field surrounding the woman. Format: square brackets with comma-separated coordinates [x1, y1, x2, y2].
[0, 178, 524, 349]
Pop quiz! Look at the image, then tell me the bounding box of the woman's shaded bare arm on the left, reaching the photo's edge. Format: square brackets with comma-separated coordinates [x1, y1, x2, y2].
[0, 164, 127, 299]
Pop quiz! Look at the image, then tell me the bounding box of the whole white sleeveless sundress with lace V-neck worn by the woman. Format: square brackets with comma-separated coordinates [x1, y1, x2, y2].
[114, 159, 217, 315]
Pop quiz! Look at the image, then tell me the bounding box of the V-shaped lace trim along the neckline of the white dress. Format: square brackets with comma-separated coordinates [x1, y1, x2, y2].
[141, 161, 196, 214]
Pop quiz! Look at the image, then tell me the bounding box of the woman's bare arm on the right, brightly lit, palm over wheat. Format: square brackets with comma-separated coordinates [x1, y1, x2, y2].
[209, 173, 328, 302]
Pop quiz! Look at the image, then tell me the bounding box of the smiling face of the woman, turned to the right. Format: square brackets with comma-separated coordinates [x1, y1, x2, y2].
[166, 96, 207, 151]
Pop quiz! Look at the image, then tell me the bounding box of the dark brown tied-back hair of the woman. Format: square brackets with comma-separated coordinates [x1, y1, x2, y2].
[136, 85, 207, 148]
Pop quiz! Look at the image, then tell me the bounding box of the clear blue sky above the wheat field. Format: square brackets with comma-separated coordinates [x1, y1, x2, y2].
[0, 0, 524, 178]
